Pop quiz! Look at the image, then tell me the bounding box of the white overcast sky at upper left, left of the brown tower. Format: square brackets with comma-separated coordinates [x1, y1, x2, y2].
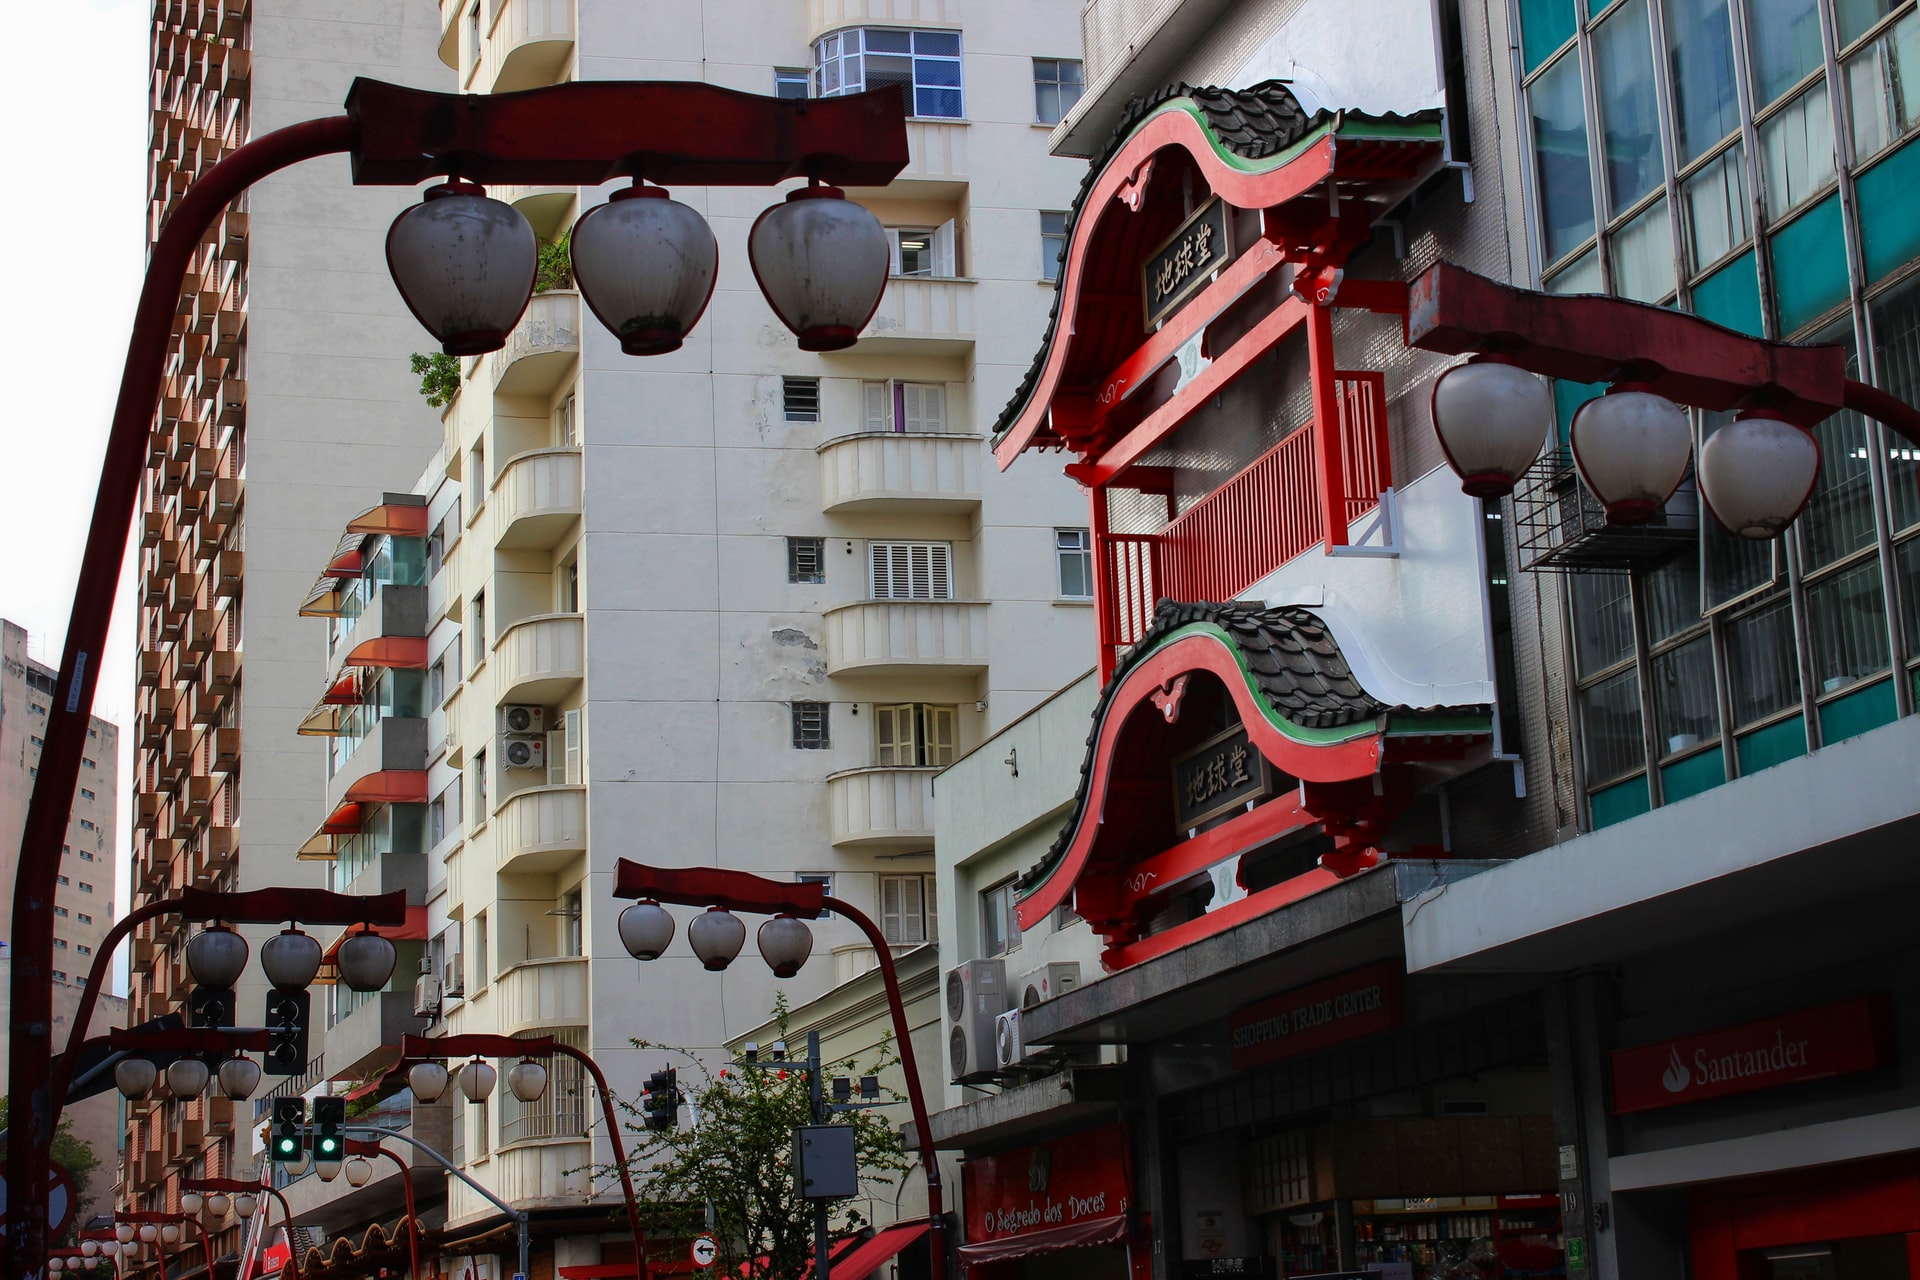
[0, 0, 150, 974]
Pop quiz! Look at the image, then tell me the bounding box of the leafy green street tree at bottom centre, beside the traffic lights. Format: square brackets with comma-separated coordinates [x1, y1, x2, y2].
[620, 998, 908, 1280]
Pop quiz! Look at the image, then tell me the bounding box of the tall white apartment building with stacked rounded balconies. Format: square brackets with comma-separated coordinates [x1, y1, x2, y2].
[270, 0, 1092, 1274]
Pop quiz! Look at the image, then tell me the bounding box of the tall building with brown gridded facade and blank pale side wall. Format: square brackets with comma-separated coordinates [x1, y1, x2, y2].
[121, 0, 447, 1251]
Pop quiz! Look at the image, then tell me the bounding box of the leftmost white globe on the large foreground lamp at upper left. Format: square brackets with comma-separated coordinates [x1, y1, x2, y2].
[386, 180, 540, 355]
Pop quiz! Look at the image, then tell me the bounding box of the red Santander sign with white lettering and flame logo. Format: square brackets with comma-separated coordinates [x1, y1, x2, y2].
[1611, 996, 1893, 1115]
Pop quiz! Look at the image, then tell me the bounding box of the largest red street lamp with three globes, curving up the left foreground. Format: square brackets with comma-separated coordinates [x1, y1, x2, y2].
[4, 79, 908, 1276]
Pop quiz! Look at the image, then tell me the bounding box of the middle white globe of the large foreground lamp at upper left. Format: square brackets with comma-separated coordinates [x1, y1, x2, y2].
[568, 180, 720, 355]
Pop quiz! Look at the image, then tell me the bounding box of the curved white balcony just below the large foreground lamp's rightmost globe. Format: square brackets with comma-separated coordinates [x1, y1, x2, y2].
[818, 432, 987, 514]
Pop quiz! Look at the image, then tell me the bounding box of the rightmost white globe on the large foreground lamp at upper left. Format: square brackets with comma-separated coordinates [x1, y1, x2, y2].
[747, 186, 891, 351]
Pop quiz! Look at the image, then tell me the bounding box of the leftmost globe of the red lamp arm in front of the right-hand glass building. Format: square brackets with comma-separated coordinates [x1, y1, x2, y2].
[1430, 355, 1553, 499]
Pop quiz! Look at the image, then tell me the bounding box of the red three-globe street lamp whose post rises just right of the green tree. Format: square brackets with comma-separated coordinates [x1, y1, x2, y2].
[612, 858, 947, 1280]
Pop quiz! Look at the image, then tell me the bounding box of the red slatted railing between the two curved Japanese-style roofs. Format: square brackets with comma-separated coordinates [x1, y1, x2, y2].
[1094, 372, 1394, 674]
